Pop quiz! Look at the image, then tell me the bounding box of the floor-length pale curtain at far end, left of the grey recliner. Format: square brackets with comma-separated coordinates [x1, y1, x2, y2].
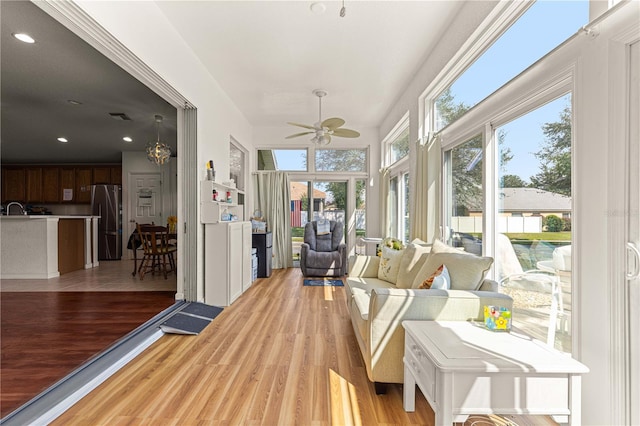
[254, 171, 293, 269]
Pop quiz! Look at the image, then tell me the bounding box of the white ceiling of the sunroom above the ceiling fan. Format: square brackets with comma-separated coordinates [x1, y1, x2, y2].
[158, 1, 463, 128]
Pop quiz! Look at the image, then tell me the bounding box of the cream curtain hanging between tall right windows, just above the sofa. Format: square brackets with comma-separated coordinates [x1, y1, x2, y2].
[411, 136, 441, 242]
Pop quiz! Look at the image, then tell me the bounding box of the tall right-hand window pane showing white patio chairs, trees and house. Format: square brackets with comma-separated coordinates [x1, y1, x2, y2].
[495, 95, 572, 352]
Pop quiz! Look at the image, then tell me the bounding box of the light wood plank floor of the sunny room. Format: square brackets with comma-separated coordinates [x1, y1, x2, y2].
[54, 269, 549, 425]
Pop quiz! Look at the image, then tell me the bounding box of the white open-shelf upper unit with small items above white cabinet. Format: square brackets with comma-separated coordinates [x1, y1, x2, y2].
[200, 180, 244, 223]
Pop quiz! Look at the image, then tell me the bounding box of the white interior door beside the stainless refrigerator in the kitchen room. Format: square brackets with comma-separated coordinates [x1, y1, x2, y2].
[123, 173, 166, 259]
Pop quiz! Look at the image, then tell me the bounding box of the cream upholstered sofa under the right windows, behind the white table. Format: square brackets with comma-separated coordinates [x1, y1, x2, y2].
[345, 240, 513, 392]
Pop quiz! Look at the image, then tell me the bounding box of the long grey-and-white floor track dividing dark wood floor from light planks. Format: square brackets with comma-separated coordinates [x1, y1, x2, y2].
[0, 300, 188, 426]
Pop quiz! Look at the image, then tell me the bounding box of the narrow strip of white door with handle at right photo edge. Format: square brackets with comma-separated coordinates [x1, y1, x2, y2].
[626, 42, 640, 425]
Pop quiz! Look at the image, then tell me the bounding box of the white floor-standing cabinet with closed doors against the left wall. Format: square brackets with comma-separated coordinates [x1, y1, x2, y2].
[204, 222, 251, 306]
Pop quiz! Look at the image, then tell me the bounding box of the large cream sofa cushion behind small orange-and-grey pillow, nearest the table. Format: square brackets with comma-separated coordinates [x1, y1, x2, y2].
[412, 252, 493, 290]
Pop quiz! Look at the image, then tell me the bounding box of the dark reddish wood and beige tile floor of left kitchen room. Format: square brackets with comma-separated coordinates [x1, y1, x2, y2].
[0, 261, 176, 417]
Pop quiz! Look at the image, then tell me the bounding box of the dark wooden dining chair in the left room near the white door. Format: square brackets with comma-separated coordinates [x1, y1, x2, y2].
[137, 224, 176, 280]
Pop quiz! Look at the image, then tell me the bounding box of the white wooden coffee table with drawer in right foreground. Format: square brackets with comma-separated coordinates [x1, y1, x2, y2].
[402, 321, 589, 426]
